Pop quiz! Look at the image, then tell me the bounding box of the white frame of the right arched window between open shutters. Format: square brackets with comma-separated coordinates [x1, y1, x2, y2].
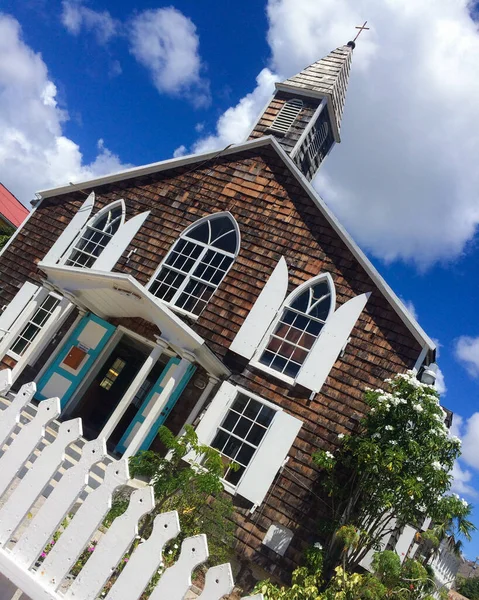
[250, 273, 336, 385]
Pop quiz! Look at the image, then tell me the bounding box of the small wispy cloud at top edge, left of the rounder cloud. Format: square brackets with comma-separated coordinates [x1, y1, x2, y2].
[61, 0, 120, 44]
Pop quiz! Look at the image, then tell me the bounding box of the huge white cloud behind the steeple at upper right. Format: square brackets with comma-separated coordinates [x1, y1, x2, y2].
[197, 0, 479, 268]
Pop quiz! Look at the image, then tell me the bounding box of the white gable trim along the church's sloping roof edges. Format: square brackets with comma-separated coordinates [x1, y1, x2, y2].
[34, 137, 436, 351]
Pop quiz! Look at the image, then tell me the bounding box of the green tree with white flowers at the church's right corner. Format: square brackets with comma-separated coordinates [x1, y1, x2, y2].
[313, 371, 475, 571]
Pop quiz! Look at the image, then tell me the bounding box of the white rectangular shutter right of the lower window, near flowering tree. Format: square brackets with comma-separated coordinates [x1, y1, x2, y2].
[236, 410, 303, 506]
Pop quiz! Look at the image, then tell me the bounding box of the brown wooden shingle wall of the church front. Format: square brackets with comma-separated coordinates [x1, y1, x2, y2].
[0, 146, 421, 575]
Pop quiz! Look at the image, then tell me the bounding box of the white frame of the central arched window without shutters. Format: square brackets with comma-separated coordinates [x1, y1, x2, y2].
[145, 211, 241, 321]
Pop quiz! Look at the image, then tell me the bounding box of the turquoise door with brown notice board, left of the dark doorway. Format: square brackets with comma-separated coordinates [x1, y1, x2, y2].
[35, 314, 116, 409]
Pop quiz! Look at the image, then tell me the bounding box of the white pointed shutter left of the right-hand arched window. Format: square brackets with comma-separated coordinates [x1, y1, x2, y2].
[230, 256, 288, 359]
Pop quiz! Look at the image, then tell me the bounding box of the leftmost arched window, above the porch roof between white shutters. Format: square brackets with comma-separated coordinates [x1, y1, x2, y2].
[65, 201, 125, 268]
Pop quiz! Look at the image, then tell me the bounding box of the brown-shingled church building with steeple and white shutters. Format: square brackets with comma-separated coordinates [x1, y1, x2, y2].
[0, 42, 435, 574]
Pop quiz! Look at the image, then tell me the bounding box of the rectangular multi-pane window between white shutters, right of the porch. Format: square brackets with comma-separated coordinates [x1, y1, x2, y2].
[210, 392, 276, 485]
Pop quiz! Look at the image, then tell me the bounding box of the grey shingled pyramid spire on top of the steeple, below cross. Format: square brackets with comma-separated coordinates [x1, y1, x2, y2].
[276, 42, 355, 142]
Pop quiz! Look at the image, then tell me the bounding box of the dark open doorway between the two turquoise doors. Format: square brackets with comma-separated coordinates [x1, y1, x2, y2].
[68, 334, 151, 440]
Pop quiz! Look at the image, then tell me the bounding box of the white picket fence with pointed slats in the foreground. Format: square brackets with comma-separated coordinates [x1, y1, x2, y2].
[0, 371, 262, 600]
